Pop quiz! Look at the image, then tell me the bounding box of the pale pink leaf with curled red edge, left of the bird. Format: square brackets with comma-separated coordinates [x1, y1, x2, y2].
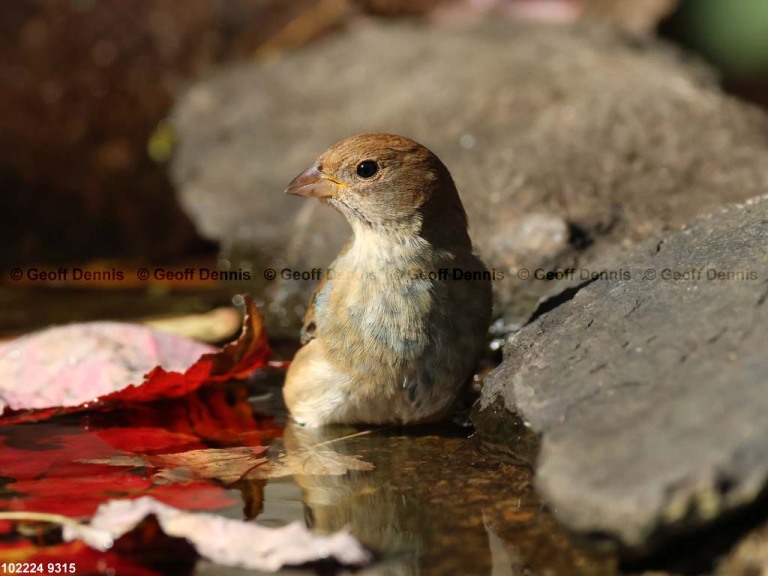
[0, 297, 270, 425]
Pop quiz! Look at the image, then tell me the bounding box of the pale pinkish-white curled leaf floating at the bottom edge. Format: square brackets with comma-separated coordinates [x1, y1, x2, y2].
[63, 496, 372, 571]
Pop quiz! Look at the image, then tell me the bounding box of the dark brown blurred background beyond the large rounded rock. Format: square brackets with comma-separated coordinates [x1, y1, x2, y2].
[0, 0, 768, 270]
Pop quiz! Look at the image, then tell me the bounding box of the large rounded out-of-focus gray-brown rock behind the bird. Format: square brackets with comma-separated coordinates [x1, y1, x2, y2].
[172, 21, 768, 335]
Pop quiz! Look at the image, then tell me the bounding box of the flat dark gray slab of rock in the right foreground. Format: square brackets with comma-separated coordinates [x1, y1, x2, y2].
[477, 196, 768, 548]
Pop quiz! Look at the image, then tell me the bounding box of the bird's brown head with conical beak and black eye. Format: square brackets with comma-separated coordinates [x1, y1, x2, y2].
[285, 134, 467, 240]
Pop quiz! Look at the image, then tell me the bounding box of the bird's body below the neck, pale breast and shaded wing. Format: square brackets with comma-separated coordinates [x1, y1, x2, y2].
[284, 232, 490, 426]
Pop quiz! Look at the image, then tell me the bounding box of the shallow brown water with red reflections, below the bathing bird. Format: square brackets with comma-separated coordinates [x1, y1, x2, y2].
[0, 290, 617, 576]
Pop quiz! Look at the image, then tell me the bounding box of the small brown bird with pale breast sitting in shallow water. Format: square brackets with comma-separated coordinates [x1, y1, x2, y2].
[283, 134, 492, 427]
